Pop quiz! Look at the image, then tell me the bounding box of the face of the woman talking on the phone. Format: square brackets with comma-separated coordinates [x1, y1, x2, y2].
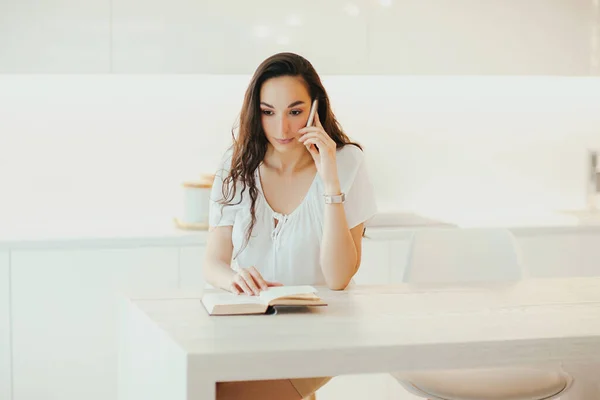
[260, 76, 311, 152]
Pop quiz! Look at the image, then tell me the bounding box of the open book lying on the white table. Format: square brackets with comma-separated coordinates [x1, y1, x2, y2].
[202, 286, 327, 315]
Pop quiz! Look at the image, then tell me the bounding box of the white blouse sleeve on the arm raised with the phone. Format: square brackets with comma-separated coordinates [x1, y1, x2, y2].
[338, 145, 377, 229]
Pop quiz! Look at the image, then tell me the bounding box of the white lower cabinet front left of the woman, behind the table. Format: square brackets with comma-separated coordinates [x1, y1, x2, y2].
[11, 247, 178, 400]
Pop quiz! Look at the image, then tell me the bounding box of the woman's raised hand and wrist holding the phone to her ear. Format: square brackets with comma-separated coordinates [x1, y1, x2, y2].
[298, 113, 339, 194]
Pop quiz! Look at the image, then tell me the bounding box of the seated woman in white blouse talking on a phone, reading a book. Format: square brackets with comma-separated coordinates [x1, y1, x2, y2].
[204, 53, 376, 400]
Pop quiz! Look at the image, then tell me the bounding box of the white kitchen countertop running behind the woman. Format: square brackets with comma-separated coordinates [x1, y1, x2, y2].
[0, 210, 600, 249]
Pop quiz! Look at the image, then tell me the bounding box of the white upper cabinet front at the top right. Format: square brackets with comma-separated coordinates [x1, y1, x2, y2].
[367, 0, 593, 76]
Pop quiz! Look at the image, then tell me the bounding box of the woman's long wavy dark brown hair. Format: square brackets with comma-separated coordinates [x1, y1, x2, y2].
[221, 53, 362, 253]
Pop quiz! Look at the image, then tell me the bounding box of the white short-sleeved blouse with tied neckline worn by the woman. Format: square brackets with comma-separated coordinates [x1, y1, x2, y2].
[209, 145, 377, 285]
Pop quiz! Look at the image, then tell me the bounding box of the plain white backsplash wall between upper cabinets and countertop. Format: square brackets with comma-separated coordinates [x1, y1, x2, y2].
[0, 75, 600, 225]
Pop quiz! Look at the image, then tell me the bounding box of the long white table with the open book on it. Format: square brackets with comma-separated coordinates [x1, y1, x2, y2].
[119, 278, 600, 400]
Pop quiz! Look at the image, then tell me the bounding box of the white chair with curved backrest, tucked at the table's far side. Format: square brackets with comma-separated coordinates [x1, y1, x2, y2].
[392, 228, 573, 400]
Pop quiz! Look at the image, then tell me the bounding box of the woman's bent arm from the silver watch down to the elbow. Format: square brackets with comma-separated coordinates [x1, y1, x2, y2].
[321, 180, 363, 290]
